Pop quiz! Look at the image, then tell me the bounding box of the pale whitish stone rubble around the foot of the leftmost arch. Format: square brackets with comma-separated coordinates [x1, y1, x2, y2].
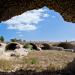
[0, 43, 30, 60]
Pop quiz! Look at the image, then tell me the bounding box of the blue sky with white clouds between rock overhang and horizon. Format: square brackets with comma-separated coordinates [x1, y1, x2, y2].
[0, 7, 75, 41]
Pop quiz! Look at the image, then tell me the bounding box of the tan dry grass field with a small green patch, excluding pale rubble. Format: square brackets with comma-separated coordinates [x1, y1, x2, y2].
[0, 50, 75, 71]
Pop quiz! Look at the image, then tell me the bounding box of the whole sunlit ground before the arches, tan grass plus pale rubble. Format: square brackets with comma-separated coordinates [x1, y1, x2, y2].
[0, 43, 75, 72]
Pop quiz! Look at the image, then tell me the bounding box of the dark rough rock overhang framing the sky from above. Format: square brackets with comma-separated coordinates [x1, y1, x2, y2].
[0, 0, 75, 23]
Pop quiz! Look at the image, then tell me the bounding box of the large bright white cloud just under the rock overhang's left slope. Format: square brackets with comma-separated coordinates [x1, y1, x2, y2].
[3, 8, 49, 31]
